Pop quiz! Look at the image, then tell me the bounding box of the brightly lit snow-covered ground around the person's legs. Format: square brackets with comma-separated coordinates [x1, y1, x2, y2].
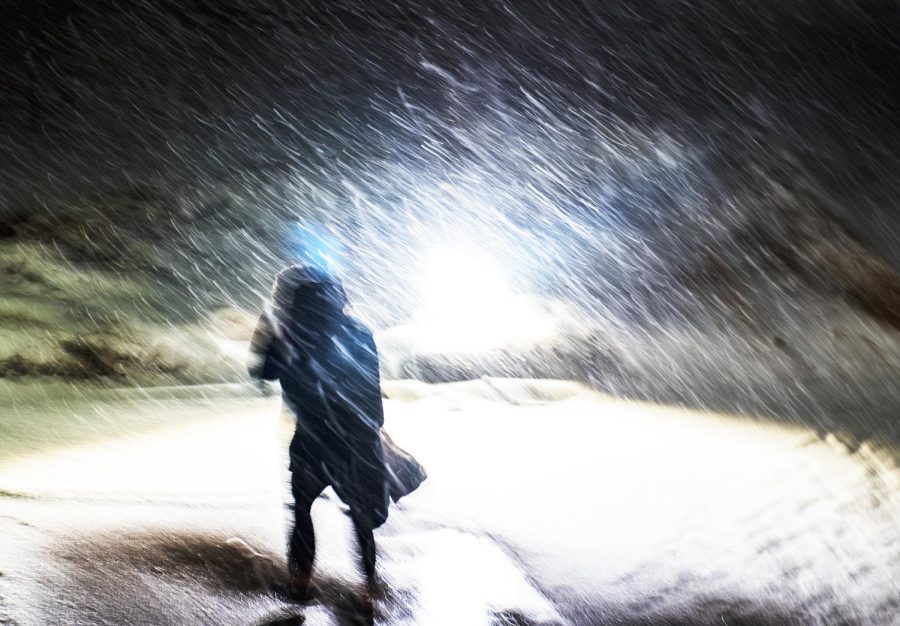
[0, 379, 900, 626]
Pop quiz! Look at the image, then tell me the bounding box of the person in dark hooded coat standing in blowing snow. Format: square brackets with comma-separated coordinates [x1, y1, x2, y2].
[249, 265, 389, 601]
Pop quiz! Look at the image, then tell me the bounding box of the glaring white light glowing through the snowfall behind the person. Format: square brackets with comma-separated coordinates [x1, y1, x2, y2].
[416, 248, 555, 352]
